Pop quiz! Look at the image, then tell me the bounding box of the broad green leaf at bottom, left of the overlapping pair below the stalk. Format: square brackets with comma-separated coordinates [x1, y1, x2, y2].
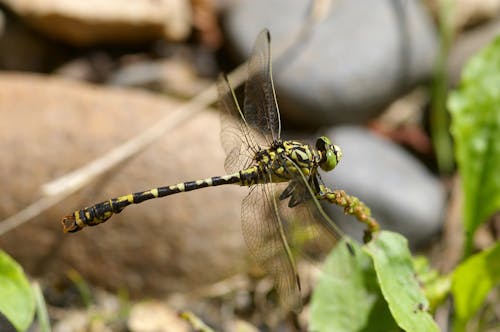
[310, 241, 399, 332]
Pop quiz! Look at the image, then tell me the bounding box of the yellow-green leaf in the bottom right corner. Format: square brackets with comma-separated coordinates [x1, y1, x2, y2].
[451, 242, 500, 331]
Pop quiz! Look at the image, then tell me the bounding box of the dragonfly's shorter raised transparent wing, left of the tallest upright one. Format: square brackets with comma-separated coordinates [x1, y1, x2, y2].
[217, 75, 257, 173]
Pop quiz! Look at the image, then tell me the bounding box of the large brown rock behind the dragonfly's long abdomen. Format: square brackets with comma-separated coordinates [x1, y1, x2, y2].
[0, 73, 246, 296]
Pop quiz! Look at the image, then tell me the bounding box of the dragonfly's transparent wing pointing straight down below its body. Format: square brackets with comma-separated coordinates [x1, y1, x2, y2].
[241, 184, 302, 311]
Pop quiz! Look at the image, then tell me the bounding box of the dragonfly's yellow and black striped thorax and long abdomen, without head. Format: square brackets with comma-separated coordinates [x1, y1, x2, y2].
[62, 141, 340, 233]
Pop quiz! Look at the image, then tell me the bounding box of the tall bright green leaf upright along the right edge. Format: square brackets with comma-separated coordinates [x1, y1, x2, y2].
[448, 38, 500, 254]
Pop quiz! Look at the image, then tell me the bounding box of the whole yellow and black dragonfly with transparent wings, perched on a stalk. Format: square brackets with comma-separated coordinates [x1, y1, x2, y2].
[62, 29, 342, 311]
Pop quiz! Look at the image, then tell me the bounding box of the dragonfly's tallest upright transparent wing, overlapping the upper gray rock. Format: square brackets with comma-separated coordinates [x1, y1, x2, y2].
[243, 29, 281, 146]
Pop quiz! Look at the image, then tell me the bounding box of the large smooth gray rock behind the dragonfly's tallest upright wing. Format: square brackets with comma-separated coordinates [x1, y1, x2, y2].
[225, 0, 437, 127]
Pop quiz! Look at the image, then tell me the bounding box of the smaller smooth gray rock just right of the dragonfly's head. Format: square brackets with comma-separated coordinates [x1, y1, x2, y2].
[323, 126, 445, 247]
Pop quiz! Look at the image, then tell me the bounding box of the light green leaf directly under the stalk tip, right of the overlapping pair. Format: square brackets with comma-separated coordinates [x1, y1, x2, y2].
[365, 231, 439, 332]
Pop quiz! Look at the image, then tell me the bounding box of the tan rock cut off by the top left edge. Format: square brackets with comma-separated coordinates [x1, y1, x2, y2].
[0, 0, 191, 45]
